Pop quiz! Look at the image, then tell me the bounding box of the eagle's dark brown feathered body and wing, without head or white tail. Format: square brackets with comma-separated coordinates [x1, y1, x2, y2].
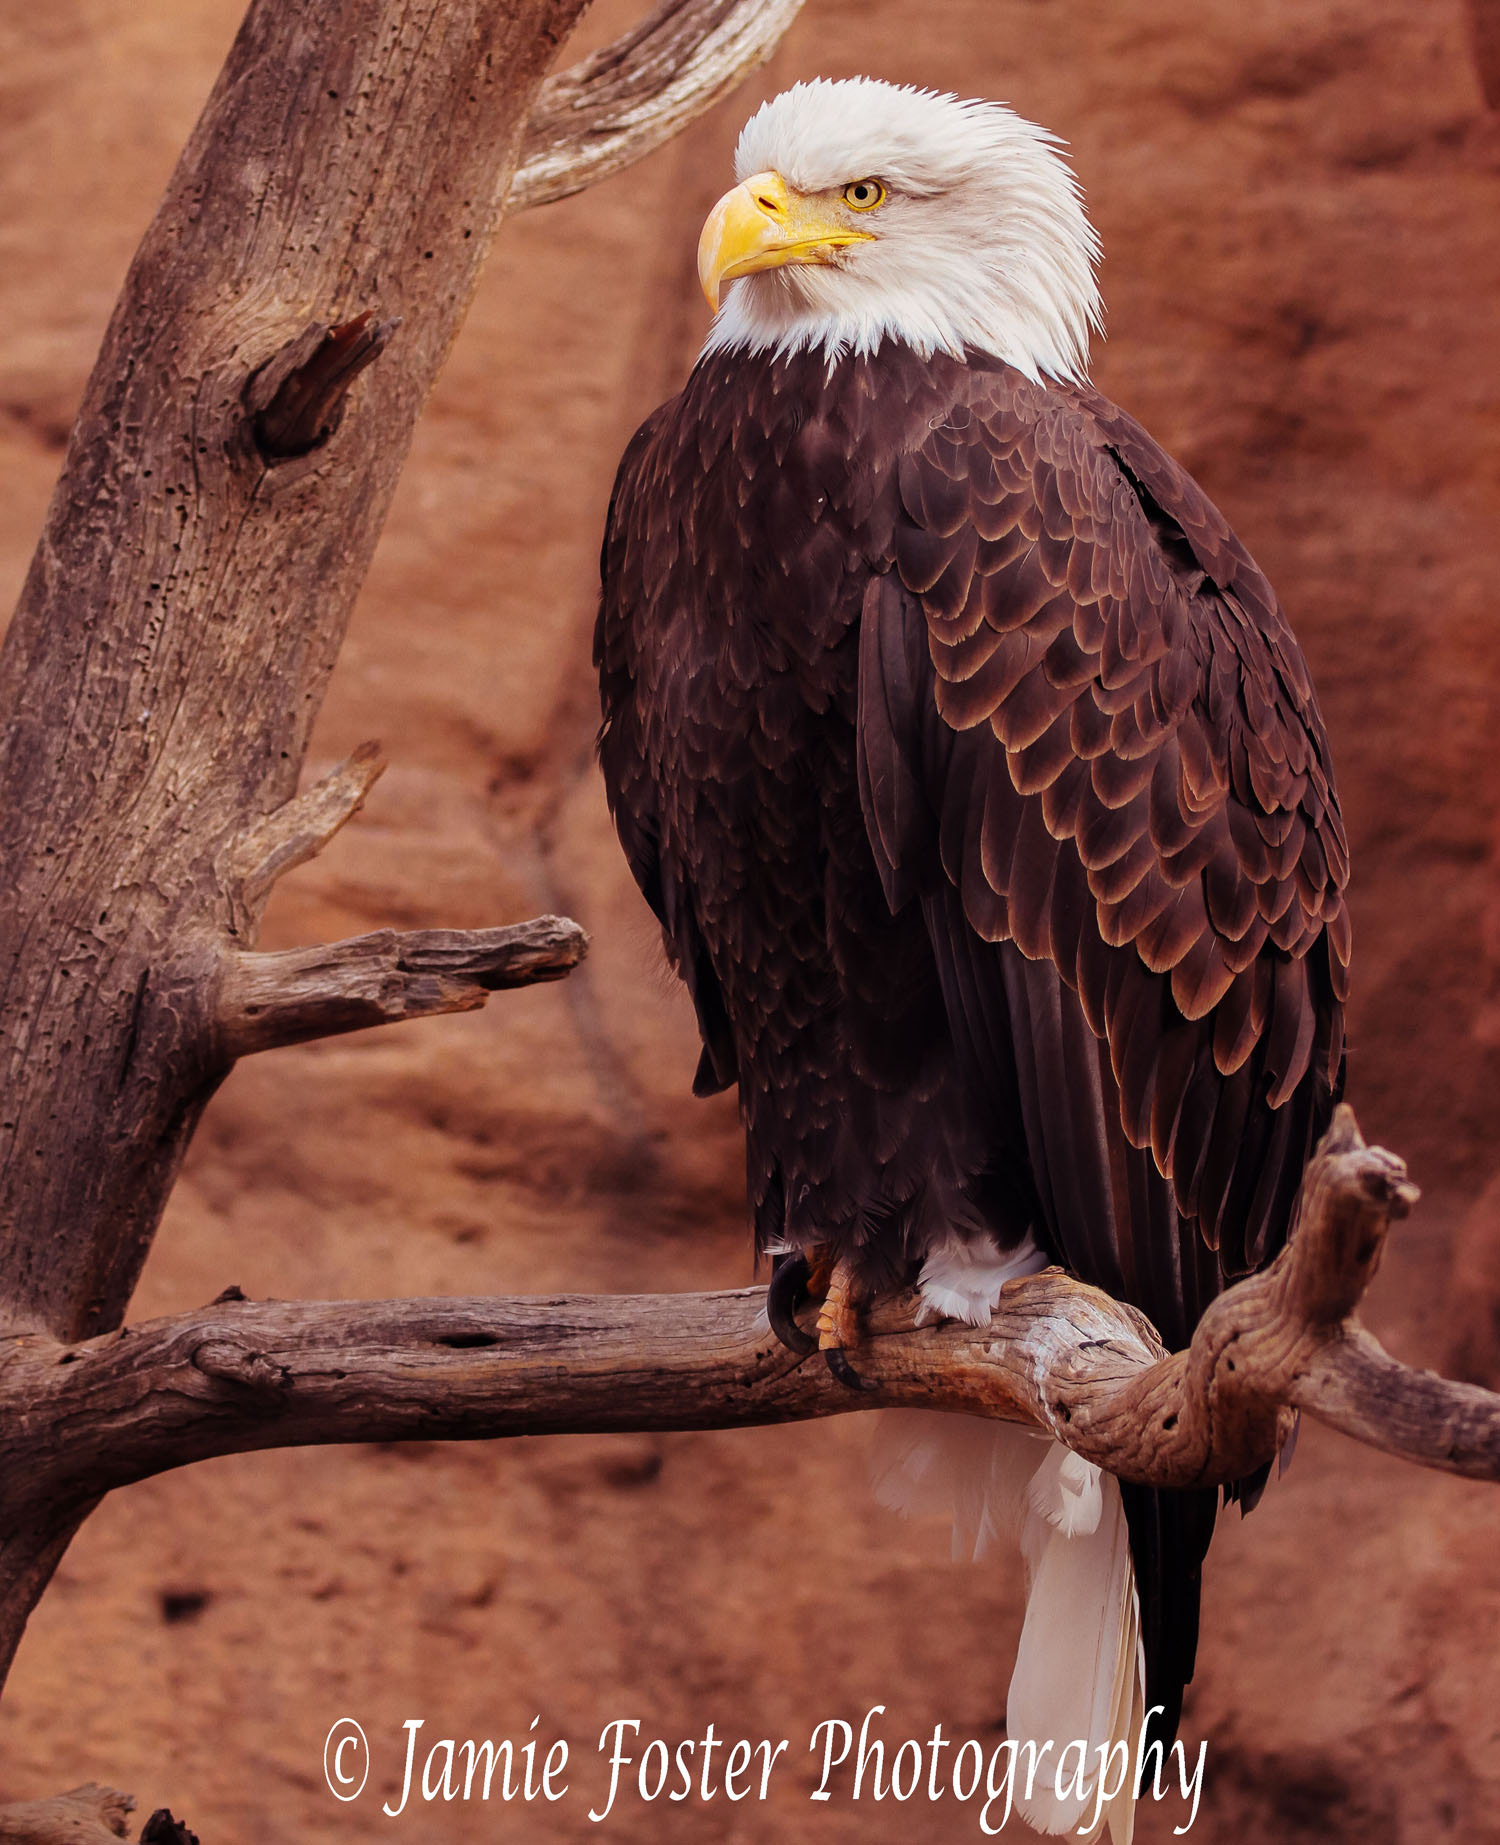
[596, 345, 1349, 1721]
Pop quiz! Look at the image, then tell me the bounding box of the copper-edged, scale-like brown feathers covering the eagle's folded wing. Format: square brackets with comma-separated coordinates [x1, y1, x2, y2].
[867, 367, 1349, 1291]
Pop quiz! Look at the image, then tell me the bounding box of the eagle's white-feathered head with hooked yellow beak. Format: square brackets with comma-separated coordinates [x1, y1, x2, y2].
[697, 77, 1100, 380]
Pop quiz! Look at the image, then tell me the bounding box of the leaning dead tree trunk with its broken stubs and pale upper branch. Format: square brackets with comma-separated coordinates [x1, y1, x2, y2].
[0, 0, 808, 1719]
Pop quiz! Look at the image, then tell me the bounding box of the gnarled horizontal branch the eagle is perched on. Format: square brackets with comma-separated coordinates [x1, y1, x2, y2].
[0, 1109, 1500, 1542]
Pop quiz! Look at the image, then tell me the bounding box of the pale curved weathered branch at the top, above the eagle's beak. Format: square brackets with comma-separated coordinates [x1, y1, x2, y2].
[506, 0, 803, 212]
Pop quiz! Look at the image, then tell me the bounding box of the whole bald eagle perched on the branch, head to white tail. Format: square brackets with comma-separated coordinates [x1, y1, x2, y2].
[594, 79, 1349, 1834]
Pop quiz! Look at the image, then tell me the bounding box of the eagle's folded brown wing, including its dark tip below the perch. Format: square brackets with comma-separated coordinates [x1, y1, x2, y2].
[858, 369, 1349, 1731]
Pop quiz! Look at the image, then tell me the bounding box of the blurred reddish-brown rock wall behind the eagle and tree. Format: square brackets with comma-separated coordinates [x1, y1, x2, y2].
[0, 0, 1500, 1845]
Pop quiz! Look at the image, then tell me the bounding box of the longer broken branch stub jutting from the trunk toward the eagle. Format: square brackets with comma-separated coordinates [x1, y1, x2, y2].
[218, 917, 589, 1057]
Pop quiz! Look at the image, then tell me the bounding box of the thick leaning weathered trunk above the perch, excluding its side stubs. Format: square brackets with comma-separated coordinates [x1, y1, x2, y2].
[0, 0, 585, 1338]
